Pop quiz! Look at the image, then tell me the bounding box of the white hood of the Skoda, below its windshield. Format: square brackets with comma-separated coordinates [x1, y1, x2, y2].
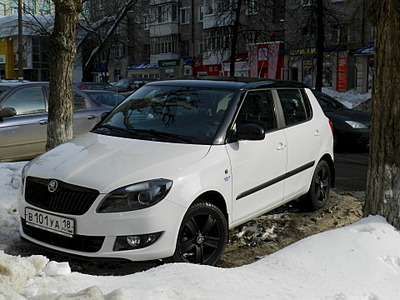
[28, 132, 210, 193]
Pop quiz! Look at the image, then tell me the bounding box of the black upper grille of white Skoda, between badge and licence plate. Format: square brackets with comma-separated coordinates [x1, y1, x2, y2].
[25, 177, 99, 215]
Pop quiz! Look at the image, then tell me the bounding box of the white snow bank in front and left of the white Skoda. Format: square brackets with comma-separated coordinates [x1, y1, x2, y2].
[0, 89, 400, 300]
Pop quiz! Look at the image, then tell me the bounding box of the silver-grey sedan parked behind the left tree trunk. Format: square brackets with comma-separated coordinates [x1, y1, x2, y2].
[0, 82, 111, 162]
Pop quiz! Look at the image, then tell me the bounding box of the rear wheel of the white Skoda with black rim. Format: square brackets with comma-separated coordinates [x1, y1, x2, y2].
[302, 160, 332, 210]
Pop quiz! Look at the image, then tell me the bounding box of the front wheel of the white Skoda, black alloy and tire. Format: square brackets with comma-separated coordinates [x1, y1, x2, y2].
[173, 200, 228, 265]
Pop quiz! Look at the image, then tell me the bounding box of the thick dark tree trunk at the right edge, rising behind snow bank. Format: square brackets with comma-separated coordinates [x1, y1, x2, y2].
[364, 0, 400, 229]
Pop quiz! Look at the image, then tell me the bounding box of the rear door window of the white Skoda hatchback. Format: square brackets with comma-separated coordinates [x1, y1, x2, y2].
[277, 89, 311, 126]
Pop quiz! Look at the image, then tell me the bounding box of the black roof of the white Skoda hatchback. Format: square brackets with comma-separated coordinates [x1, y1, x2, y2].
[146, 77, 307, 90]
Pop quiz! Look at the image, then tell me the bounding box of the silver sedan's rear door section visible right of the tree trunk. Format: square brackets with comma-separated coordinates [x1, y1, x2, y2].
[74, 91, 99, 136]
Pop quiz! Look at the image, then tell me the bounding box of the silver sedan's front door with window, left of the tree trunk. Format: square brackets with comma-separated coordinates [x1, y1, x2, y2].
[0, 86, 47, 160]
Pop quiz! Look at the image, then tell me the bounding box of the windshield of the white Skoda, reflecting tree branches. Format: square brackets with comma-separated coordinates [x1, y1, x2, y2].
[94, 85, 235, 144]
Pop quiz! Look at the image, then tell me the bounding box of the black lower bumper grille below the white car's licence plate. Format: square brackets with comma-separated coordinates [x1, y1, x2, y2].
[21, 218, 105, 252]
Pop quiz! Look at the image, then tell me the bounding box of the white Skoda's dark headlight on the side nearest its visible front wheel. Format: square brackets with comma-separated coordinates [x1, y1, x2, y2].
[97, 179, 172, 213]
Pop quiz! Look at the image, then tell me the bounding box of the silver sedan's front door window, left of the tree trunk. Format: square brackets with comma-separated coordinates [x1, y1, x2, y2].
[3, 86, 46, 115]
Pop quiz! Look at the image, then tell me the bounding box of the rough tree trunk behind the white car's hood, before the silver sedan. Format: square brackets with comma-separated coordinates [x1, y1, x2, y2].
[46, 0, 83, 150]
